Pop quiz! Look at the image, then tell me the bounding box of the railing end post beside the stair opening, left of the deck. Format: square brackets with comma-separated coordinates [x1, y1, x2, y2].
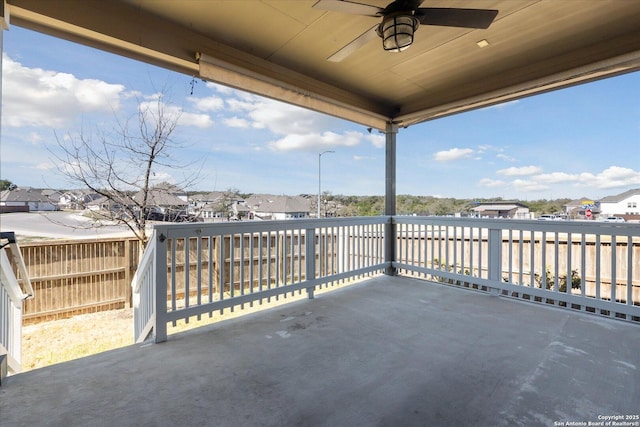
[153, 228, 166, 343]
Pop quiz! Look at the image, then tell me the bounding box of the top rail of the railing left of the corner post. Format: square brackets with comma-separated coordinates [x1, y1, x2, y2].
[153, 216, 391, 238]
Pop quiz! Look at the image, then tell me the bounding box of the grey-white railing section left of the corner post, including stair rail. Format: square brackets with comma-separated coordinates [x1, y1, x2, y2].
[132, 217, 391, 342]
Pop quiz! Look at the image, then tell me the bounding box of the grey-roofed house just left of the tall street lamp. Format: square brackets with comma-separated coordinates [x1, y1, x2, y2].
[245, 194, 311, 220]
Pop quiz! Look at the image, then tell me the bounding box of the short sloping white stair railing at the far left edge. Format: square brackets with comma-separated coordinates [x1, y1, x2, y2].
[0, 232, 33, 372]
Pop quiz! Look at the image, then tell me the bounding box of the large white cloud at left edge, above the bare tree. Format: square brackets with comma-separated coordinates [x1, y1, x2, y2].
[2, 55, 125, 127]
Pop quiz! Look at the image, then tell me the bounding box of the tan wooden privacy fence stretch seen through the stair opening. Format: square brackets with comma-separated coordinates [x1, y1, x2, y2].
[20, 238, 139, 324]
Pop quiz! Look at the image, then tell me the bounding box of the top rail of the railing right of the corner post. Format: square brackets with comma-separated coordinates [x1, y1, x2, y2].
[393, 216, 640, 237]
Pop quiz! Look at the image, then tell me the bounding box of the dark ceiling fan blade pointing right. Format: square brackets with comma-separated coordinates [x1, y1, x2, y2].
[415, 7, 498, 29]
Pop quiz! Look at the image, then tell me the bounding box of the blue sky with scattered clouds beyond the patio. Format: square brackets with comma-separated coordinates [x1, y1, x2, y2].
[0, 26, 640, 200]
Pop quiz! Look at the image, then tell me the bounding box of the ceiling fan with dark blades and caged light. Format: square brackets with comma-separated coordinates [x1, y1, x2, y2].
[313, 0, 498, 62]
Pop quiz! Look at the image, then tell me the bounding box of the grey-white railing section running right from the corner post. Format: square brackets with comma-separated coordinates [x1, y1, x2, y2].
[394, 217, 640, 321]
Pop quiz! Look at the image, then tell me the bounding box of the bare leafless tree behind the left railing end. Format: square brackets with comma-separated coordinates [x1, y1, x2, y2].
[52, 92, 199, 249]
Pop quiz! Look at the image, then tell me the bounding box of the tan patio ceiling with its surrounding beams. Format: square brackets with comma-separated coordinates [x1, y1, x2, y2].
[6, 0, 640, 130]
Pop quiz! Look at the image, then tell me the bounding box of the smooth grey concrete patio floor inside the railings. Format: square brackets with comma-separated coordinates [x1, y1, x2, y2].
[0, 276, 640, 427]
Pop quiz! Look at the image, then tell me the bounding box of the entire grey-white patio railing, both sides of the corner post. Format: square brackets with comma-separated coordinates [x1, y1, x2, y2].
[133, 216, 640, 342]
